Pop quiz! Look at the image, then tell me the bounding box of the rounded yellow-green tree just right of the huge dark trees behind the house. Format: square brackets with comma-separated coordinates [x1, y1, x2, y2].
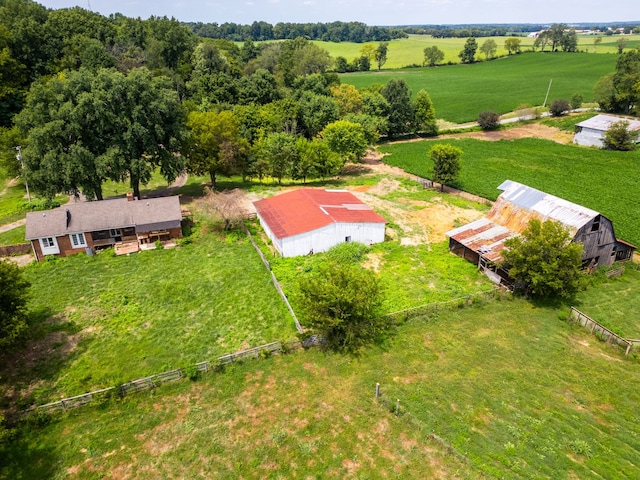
[182, 110, 249, 190]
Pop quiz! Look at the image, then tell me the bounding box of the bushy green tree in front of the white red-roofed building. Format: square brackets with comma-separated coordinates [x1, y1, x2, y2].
[298, 261, 392, 354]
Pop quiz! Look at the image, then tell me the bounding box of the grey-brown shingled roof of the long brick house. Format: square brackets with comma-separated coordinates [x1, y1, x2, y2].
[26, 196, 182, 240]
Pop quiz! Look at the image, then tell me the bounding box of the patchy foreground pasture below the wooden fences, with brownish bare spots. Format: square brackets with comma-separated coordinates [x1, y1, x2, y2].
[2, 294, 640, 480]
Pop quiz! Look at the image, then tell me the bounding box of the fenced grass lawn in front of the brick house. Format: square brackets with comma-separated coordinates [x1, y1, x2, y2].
[2, 228, 296, 407]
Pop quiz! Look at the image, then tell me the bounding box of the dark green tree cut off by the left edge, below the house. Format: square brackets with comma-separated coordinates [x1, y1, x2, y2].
[0, 260, 30, 349]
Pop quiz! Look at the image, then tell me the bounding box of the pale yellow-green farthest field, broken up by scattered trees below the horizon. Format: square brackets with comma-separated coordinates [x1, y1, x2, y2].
[318, 35, 640, 70]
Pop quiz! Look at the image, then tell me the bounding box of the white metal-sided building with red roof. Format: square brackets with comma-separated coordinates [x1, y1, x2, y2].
[254, 188, 387, 257]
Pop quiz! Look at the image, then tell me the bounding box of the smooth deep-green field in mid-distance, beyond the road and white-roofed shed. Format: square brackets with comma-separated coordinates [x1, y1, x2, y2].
[340, 52, 618, 123]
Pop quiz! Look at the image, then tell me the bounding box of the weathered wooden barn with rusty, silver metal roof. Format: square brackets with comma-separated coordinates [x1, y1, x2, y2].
[447, 180, 636, 283]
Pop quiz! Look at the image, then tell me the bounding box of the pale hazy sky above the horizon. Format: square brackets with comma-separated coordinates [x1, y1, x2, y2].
[42, 0, 640, 26]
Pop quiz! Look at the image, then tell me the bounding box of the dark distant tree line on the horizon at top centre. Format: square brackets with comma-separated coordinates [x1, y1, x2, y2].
[185, 22, 407, 43]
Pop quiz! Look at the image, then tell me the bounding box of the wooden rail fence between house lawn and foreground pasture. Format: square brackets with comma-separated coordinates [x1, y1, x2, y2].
[29, 337, 320, 414]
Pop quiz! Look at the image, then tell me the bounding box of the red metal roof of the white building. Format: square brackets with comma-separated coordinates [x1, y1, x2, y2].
[253, 188, 387, 238]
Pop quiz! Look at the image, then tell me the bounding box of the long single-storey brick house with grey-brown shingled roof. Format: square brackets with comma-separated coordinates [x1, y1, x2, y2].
[26, 194, 182, 261]
